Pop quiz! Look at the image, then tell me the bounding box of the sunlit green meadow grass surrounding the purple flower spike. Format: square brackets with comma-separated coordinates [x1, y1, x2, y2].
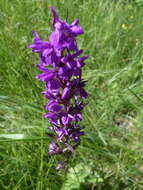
[0, 0, 143, 190]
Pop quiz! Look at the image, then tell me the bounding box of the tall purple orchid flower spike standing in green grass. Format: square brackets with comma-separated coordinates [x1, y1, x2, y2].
[28, 7, 88, 168]
